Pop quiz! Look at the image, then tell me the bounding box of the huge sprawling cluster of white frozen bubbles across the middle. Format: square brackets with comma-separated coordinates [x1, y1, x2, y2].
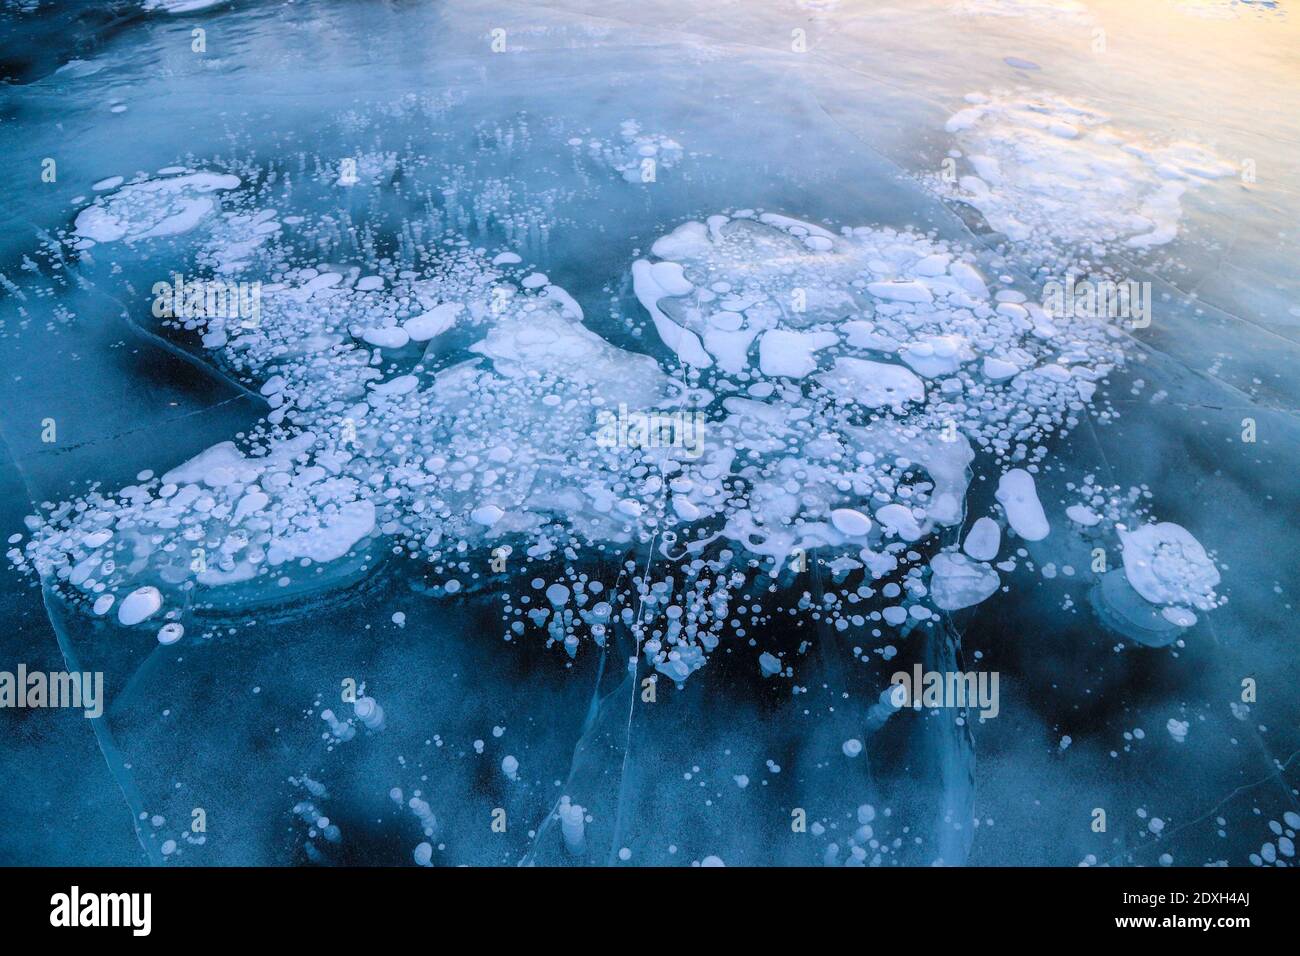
[9, 102, 1221, 682]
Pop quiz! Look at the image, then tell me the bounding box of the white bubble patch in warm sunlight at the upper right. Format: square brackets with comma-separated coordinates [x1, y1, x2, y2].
[946, 90, 1234, 254]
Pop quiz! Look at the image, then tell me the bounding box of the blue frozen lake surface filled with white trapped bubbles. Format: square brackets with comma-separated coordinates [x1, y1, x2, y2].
[0, 0, 1300, 866]
